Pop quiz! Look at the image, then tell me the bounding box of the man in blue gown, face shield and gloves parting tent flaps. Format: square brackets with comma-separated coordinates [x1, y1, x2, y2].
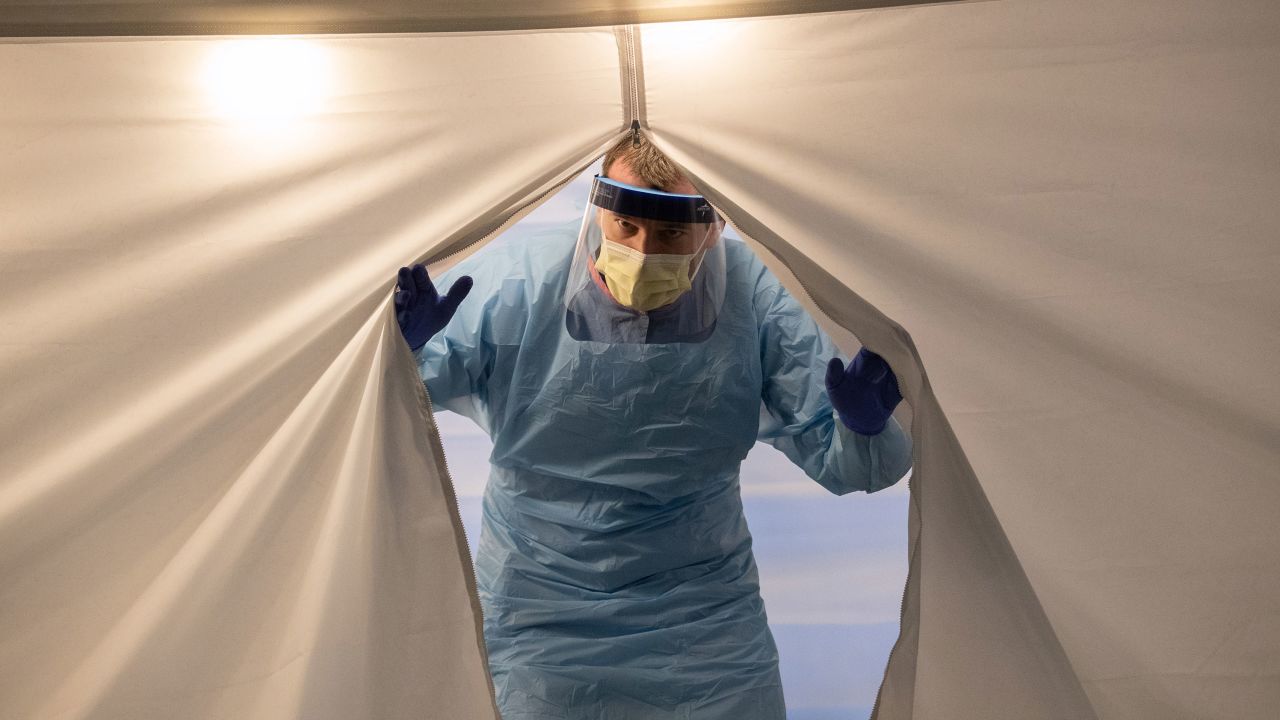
[396, 137, 911, 720]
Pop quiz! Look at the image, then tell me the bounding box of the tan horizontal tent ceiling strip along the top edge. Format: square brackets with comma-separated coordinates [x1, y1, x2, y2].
[0, 0, 957, 37]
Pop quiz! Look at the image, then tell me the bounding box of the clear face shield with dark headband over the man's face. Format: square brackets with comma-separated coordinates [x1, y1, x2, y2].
[564, 176, 724, 343]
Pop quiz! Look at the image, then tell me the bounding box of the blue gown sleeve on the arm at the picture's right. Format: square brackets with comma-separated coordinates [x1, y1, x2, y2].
[756, 268, 911, 495]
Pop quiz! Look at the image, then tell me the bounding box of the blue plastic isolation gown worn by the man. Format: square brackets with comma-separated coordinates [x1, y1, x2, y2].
[416, 224, 911, 720]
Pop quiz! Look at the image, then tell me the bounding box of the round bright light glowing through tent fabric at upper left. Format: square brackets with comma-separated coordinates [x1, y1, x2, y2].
[205, 37, 330, 127]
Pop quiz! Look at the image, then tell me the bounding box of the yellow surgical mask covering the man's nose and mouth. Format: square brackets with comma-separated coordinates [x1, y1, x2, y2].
[595, 240, 694, 313]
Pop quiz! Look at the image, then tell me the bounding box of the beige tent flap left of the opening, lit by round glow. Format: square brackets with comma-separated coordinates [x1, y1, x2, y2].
[0, 31, 622, 720]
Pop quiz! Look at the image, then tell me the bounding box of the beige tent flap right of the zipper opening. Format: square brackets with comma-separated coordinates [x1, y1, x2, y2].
[643, 0, 1280, 720]
